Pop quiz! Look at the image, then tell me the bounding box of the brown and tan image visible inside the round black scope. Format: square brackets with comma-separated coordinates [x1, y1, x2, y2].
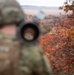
[24, 28, 35, 41]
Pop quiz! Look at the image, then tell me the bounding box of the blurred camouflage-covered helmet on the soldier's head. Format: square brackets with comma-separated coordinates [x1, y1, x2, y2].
[0, 0, 24, 25]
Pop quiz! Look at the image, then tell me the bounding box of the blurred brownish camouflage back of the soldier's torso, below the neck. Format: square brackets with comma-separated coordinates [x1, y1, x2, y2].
[0, 33, 21, 75]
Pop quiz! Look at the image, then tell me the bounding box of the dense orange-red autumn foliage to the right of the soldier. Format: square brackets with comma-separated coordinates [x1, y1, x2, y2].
[40, 26, 74, 75]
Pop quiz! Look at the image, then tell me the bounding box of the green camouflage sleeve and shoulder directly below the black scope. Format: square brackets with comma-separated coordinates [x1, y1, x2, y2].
[20, 45, 52, 75]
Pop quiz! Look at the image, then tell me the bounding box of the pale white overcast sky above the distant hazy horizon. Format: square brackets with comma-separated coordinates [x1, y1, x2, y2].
[17, 0, 65, 7]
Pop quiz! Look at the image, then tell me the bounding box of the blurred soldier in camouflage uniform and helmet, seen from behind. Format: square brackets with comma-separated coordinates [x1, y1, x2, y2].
[0, 0, 52, 75]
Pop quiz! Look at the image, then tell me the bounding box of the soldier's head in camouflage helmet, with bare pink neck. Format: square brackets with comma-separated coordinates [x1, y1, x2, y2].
[0, 0, 25, 33]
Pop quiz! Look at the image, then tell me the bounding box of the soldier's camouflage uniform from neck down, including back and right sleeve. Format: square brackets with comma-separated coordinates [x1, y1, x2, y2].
[0, 33, 52, 75]
